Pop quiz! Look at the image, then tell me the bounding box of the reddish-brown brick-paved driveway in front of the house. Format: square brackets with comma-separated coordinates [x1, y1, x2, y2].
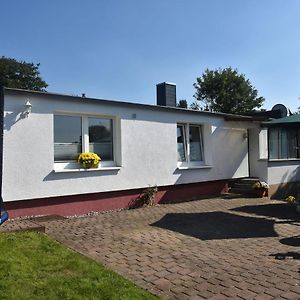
[38, 199, 300, 299]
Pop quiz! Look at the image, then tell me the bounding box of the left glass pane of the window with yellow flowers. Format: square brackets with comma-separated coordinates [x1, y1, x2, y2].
[54, 116, 82, 161]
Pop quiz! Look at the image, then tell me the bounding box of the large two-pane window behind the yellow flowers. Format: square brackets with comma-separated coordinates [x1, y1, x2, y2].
[54, 115, 114, 162]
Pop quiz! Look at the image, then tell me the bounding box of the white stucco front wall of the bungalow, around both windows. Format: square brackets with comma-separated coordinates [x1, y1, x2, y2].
[3, 91, 254, 201]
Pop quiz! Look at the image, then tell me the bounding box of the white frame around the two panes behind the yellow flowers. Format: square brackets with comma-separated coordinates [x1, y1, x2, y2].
[53, 112, 118, 170]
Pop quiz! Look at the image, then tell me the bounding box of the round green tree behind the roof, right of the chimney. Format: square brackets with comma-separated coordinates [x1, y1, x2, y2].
[194, 68, 265, 114]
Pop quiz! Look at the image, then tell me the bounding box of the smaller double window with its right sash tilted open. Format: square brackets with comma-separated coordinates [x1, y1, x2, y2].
[177, 124, 204, 166]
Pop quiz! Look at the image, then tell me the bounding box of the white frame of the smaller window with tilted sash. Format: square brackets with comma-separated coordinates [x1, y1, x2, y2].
[176, 123, 205, 168]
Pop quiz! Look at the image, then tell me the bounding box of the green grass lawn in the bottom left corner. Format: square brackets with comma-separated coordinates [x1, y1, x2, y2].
[0, 232, 158, 300]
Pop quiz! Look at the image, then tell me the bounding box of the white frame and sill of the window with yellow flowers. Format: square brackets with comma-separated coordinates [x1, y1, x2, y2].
[53, 112, 120, 172]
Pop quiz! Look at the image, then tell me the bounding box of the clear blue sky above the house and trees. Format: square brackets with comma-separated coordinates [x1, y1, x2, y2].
[0, 0, 300, 111]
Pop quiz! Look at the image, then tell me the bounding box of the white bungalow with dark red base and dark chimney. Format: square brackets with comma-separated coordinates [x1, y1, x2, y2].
[1, 83, 296, 217]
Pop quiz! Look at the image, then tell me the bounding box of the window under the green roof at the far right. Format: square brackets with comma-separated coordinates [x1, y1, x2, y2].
[268, 127, 300, 159]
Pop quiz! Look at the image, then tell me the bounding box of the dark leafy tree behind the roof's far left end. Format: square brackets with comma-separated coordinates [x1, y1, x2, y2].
[0, 56, 48, 91]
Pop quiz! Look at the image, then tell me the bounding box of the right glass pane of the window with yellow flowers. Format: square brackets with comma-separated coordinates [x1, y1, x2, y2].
[89, 118, 114, 160]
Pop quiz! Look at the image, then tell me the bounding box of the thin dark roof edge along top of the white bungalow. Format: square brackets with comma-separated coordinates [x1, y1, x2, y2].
[4, 87, 265, 122]
